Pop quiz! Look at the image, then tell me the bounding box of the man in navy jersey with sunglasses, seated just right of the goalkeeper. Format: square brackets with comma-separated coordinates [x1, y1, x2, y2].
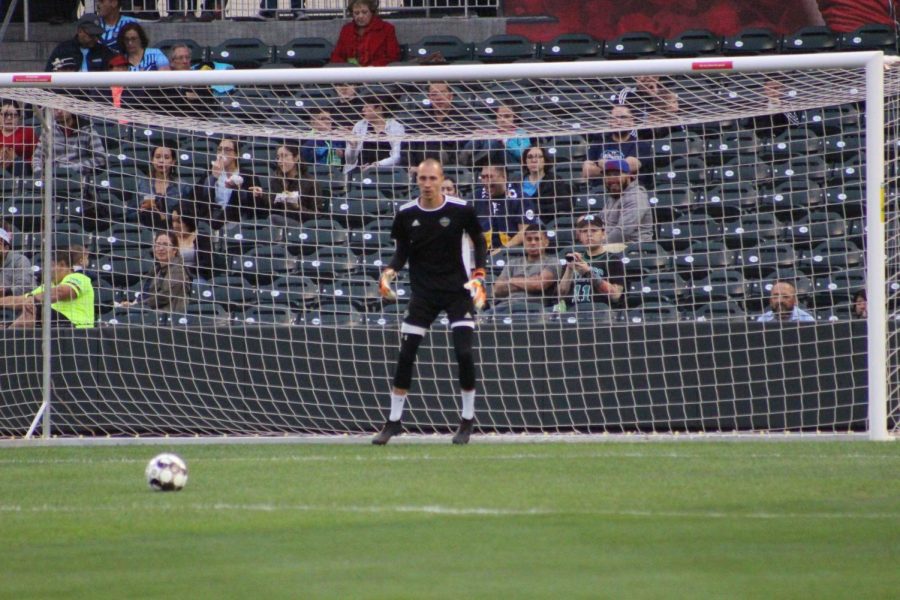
[475, 157, 540, 254]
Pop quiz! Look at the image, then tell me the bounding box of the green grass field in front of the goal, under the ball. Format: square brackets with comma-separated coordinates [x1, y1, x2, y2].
[0, 441, 900, 599]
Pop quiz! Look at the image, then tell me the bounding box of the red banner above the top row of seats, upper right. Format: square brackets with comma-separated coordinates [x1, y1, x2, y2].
[504, 0, 894, 41]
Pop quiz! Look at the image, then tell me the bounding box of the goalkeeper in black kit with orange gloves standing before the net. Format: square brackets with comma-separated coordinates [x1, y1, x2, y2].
[372, 159, 487, 445]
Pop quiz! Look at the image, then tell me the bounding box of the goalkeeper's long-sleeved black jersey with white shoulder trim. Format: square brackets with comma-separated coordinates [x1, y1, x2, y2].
[390, 196, 487, 294]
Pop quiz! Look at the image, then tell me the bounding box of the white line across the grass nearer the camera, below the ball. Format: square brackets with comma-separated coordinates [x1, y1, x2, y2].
[0, 502, 900, 521]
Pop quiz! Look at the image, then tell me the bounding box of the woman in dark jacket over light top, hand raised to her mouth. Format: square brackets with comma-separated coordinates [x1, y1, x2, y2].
[194, 138, 260, 230]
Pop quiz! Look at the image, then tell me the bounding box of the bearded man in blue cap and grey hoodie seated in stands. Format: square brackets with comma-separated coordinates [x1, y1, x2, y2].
[602, 159, 653, 244]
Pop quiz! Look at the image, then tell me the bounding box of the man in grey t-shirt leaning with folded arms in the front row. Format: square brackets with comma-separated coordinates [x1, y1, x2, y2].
[492, 223, 559, 312]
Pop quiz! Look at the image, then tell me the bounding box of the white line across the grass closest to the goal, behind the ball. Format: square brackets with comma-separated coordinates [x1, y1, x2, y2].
[0, 450, 900, 466]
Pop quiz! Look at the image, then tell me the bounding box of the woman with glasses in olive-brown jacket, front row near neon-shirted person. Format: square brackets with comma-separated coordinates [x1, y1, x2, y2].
[119, 231, 191, 313]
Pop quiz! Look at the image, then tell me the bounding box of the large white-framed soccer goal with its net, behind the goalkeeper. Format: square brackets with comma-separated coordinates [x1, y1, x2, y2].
[0, 52, 900, 439]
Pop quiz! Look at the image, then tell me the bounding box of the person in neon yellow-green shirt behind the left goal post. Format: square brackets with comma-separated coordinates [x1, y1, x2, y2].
[0, 248, 94, 329]
